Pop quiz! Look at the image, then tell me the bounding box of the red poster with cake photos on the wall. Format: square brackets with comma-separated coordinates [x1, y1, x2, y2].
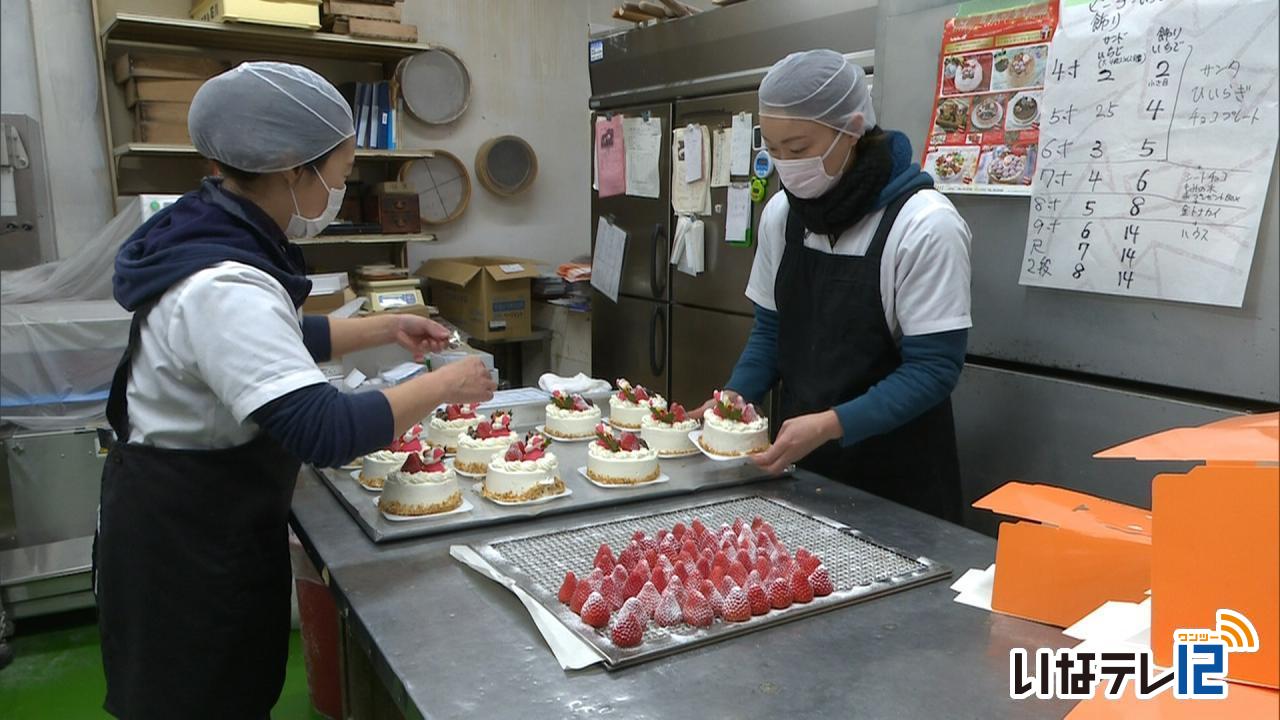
[920, 0, 1057, 196]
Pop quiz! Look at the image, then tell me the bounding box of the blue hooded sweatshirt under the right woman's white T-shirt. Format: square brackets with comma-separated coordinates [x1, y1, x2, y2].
[724, 131, 969, 447]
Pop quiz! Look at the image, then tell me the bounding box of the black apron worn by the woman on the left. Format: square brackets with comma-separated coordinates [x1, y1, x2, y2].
[93, 306, 301, 719]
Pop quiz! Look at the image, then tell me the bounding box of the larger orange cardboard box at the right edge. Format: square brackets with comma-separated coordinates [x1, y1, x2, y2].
[1095, 413, 1280, 688]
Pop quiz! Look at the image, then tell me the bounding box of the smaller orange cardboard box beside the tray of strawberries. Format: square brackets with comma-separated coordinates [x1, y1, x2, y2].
[973, 482, 1151, 628]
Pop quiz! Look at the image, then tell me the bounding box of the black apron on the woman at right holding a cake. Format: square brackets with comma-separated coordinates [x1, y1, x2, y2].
[774, 184, 960, 521]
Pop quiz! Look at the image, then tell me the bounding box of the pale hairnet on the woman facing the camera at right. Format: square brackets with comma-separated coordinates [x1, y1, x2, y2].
[759, 50, 876, 137]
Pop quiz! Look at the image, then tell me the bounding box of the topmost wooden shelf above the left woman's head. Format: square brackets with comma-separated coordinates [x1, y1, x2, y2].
[102, 13, 430, 63]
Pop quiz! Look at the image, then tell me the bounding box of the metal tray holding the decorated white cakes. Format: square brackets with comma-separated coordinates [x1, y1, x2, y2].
[314, 442, 788, 540]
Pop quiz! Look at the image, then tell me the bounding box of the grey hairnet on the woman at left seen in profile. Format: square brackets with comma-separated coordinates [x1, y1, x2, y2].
[187, 63, 356, 173]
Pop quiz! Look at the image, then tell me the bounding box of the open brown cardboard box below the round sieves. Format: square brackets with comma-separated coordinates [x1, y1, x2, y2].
[417, 256, 538, 341]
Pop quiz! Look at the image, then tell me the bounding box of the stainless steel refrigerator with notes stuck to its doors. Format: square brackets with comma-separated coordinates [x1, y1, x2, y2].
[590, 0, 876, 416]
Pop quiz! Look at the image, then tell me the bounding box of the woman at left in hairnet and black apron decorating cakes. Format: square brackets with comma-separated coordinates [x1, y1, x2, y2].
[93, 63, 494, 717]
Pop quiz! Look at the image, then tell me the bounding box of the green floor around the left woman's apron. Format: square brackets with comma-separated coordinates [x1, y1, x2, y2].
[0, 604, 320, 720]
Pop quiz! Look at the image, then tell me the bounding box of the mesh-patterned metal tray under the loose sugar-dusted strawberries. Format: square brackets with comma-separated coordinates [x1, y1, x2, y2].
[472, 496, 951, 670]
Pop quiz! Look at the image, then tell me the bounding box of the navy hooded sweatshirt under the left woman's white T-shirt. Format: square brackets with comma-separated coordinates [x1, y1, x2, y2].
[113, 178, 396, 466]
